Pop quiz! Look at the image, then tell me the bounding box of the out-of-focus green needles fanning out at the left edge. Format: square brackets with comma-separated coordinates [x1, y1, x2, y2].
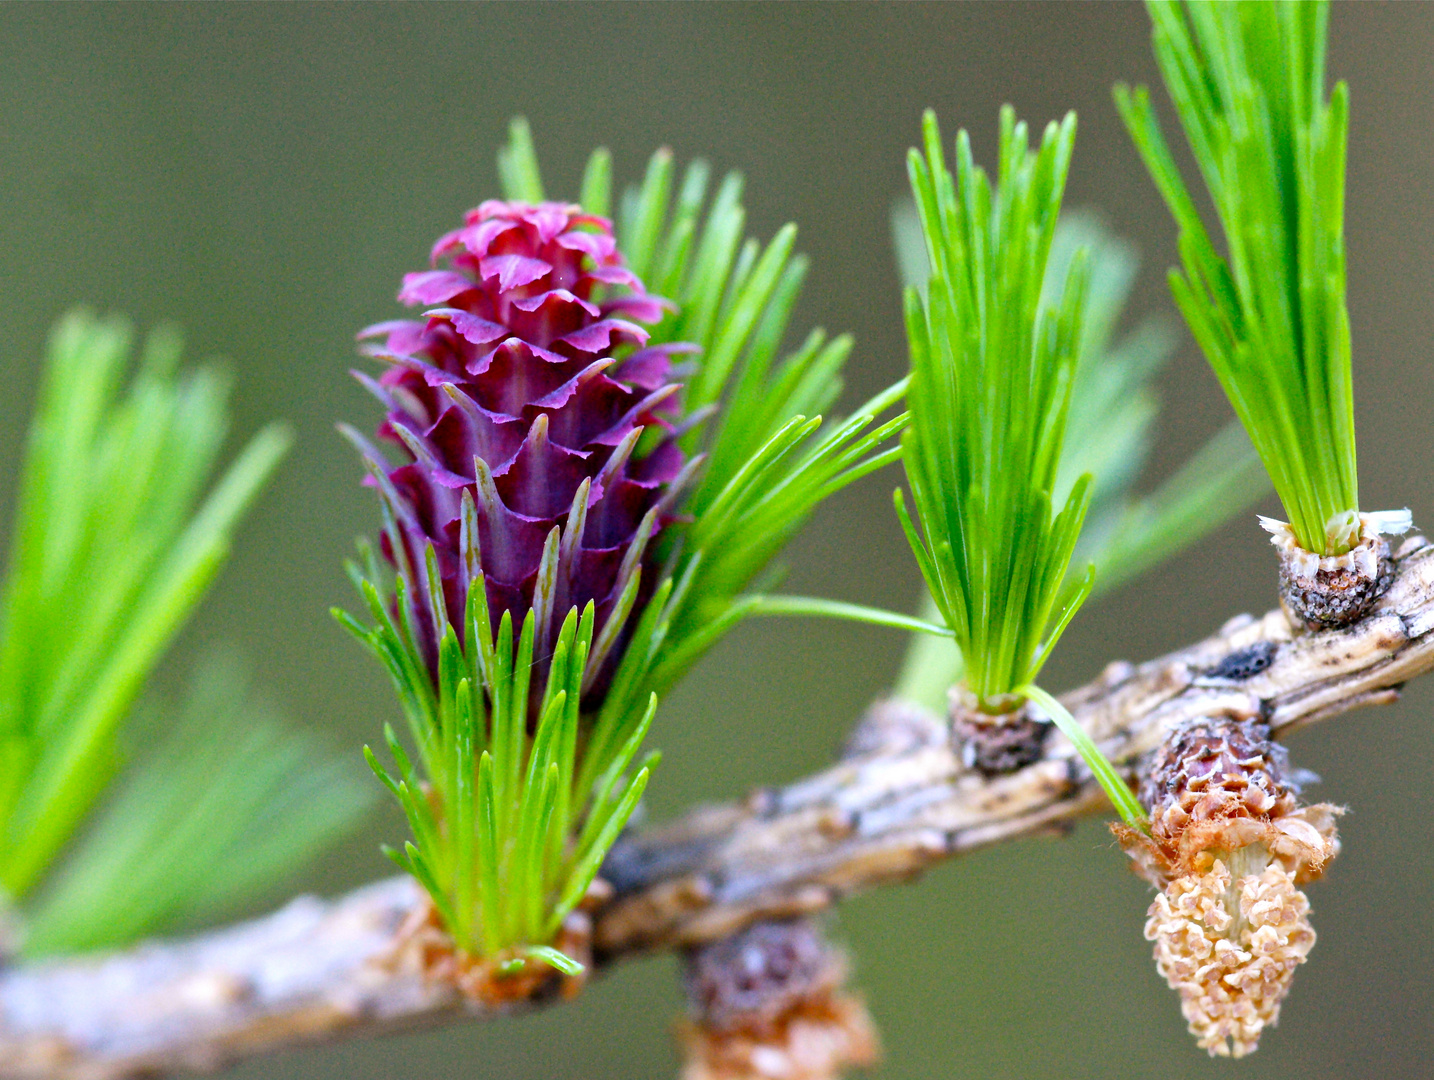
[0, 311, 369, 957]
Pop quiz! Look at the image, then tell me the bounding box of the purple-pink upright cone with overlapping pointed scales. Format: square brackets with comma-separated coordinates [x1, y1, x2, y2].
[356, 201, 694, 707]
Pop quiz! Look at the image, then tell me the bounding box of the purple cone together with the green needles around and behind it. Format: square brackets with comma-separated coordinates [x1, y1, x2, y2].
[340, 120, 905, 975]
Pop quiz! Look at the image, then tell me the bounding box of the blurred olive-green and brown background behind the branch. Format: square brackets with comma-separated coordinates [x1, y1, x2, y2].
[0, 3, 1434, 1080]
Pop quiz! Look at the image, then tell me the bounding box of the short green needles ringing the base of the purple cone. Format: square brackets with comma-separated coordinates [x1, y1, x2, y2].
[343, 565, 657, 975]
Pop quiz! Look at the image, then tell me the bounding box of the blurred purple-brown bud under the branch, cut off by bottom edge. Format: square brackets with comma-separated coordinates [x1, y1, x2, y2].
[678, 919, 880, 1080]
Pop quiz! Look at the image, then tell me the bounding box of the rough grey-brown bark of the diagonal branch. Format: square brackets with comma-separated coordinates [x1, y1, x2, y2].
[0, 538, 1434, 1080]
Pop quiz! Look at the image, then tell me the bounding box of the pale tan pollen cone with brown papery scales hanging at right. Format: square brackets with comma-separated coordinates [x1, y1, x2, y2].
[1114, 717, 1339, 1057]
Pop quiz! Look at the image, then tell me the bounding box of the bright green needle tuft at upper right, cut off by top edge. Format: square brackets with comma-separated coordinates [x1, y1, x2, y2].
[1116, 0, 1359, 555]
